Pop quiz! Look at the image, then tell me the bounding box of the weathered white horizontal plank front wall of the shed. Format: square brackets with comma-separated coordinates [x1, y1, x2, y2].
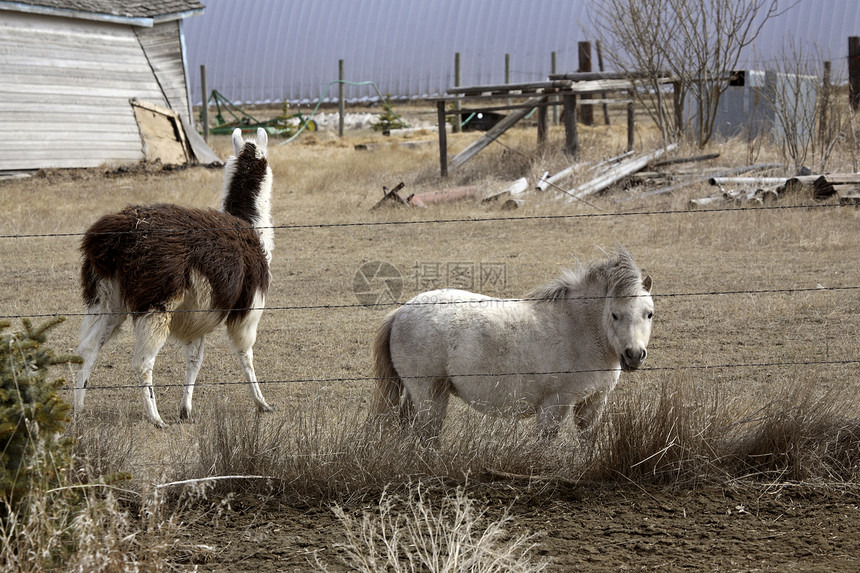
[0, 11, 170, 170]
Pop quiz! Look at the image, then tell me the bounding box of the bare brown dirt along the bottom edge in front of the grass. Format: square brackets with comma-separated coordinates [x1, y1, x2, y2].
[178, 484, 860, 572]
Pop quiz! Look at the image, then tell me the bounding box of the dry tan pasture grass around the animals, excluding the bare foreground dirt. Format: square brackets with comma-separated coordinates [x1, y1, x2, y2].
[0, 104, 860, 559]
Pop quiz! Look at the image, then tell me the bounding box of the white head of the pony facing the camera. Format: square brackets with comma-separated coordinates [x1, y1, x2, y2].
[603, 255, 654, 371]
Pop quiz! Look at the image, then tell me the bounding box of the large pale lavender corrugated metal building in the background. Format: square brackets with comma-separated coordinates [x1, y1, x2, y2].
[185, 0, 860, 104]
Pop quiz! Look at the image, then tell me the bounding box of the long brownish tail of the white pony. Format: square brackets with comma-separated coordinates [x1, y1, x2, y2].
[372, 312, 412, 423]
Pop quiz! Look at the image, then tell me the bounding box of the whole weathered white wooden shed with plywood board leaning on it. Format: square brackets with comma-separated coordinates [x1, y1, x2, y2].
[0, 0, 220, 171]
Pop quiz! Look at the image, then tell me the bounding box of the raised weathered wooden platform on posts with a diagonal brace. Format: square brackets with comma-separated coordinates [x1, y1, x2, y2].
[428, 72, 674, 177]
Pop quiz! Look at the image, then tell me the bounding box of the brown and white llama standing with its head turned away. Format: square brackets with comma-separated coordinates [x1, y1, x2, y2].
[75, 129, 273, 427]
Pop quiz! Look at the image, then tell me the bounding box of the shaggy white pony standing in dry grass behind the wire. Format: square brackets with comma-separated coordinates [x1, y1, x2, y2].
[373, 247, 654, 441]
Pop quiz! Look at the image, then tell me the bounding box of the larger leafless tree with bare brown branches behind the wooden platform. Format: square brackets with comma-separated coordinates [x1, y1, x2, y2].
[592, 0, 783, 147]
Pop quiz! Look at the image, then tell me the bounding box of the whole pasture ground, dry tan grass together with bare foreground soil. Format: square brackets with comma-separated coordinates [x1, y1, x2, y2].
[0, 104, 860, 571]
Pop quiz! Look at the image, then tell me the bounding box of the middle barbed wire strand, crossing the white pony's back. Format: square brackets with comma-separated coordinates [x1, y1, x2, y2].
[0, 286, 860, 320]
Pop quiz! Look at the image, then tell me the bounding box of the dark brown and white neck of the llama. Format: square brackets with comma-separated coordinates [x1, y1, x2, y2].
[221, 157, 275, 261]
